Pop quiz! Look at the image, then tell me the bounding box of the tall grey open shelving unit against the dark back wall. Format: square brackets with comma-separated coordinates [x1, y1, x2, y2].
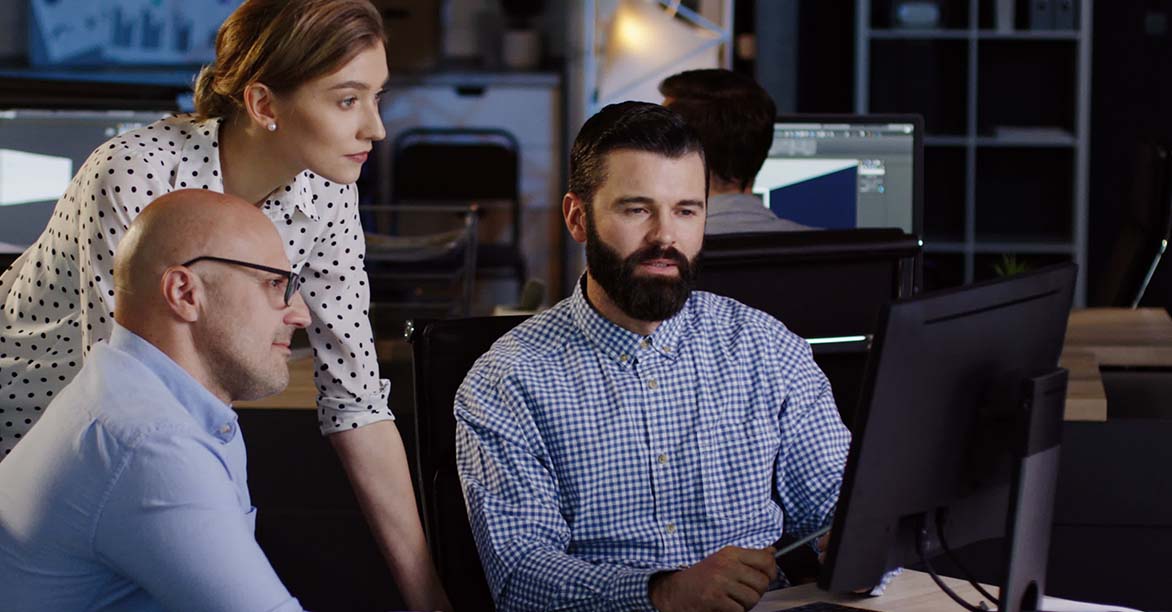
[854, 0, 1092, 306]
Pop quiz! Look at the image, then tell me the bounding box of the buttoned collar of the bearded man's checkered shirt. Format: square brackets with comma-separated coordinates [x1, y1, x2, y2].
[570, 274, 691, 366]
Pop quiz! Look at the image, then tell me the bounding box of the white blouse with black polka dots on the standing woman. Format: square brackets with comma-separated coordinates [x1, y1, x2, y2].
[0, 115, 394, 458]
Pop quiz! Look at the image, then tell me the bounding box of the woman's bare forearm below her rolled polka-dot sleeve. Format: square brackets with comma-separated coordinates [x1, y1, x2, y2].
[329, 421, 451, 610]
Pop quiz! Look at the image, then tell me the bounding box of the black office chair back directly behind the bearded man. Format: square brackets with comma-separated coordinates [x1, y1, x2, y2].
[409, 315, 529, 610]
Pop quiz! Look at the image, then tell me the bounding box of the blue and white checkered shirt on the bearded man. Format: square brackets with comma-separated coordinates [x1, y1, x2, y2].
[455, 279, 850, 611]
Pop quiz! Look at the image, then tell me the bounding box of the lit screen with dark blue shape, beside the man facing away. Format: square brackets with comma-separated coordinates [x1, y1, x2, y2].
[752, 122, 915, 233]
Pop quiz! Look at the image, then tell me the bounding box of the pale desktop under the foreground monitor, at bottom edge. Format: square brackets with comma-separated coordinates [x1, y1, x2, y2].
[750, 570, 979, 612]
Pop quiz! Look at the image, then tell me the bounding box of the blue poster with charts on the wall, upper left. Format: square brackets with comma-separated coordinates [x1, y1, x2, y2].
[28, 0, 240, 67]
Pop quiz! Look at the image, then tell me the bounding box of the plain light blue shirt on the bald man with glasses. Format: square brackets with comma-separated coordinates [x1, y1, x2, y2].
[0, 326, 301, 612]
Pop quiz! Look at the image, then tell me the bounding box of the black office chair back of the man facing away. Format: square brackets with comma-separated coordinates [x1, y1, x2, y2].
[697, 229, 920, 427]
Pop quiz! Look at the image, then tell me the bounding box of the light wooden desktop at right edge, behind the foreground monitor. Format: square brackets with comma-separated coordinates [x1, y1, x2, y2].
[1059, 308, 1172, 421]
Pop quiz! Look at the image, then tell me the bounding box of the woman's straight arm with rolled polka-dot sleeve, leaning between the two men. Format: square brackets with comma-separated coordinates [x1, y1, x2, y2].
[301, 184, 451, 610]
